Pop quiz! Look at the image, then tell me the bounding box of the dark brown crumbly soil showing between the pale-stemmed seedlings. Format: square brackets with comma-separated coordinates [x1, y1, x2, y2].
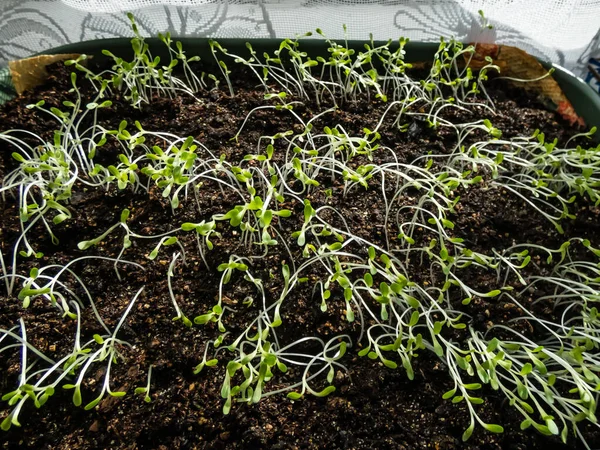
[0, 60, 600, 450]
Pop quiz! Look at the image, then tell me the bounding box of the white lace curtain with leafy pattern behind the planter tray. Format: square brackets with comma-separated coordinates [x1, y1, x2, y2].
[0, 0, 600, 77]
